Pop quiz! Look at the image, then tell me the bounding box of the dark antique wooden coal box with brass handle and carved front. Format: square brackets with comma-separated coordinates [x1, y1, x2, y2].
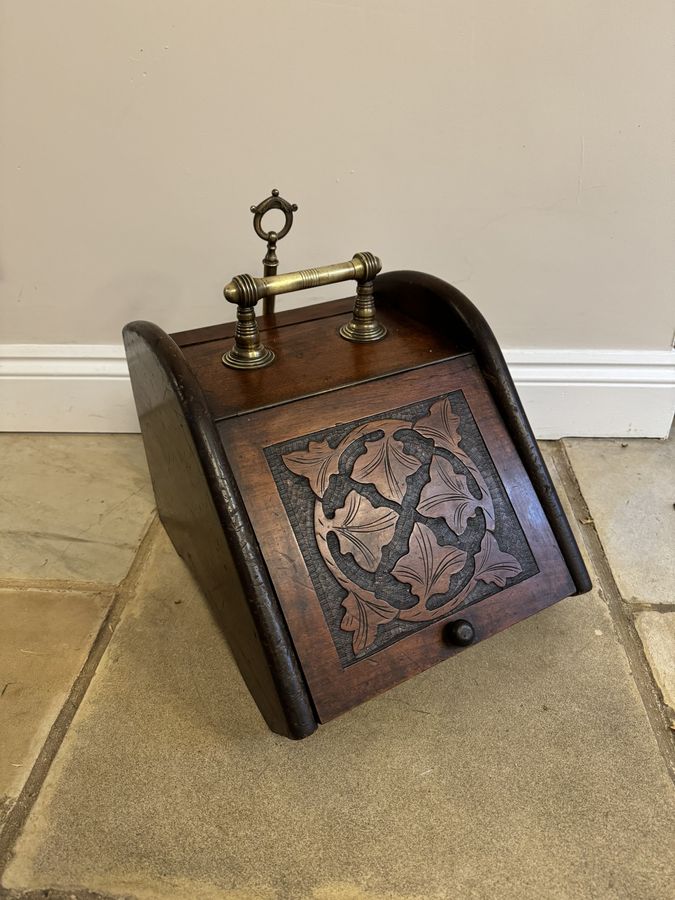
[124, 246, 590, 738]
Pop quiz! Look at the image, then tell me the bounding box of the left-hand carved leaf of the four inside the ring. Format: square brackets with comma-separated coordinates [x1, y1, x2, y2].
[329, 491, 398, 572]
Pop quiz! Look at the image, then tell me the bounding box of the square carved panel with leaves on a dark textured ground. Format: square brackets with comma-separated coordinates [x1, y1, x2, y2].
[264, 390, 539, 668]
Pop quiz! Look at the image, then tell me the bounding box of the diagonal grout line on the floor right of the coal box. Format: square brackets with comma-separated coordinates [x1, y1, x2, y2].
[552, 441, 675, 781]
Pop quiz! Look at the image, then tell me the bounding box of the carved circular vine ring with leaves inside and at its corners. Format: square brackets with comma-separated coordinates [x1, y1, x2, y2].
[283, 398, 522, 654]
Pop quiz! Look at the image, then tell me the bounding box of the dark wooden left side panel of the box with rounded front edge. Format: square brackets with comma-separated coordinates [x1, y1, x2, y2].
[124, 323, 317, 738]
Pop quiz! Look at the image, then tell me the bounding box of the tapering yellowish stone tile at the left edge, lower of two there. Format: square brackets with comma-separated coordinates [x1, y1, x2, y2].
[0, 590, 109, 824]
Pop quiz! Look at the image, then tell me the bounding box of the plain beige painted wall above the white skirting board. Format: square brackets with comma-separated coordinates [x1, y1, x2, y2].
[0, 0, 675, 349]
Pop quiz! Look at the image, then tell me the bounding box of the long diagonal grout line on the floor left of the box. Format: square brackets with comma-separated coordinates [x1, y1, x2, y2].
[0, 513, 161, 900]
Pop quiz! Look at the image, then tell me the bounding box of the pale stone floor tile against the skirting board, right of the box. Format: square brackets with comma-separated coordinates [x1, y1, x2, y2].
[564, 437, 675, 603]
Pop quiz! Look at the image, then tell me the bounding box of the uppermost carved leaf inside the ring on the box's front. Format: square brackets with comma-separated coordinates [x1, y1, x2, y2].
[352, 419, 422, 503]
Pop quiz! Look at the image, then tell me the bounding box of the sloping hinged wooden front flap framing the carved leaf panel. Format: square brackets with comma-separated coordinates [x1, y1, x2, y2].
[218, 354, 575, 721]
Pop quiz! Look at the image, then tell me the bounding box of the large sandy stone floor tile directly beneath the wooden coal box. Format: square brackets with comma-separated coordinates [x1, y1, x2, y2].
[3, 534, 675, 900]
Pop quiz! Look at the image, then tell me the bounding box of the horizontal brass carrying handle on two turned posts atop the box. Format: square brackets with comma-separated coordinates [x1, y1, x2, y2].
[223, 251, 387, 369]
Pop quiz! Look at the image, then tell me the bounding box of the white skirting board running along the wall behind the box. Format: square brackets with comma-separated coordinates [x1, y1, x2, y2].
[0, 344, 675, 439]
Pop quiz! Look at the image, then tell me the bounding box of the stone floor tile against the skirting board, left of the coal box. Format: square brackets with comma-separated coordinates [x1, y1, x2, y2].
[0, 434, 154, 584]
